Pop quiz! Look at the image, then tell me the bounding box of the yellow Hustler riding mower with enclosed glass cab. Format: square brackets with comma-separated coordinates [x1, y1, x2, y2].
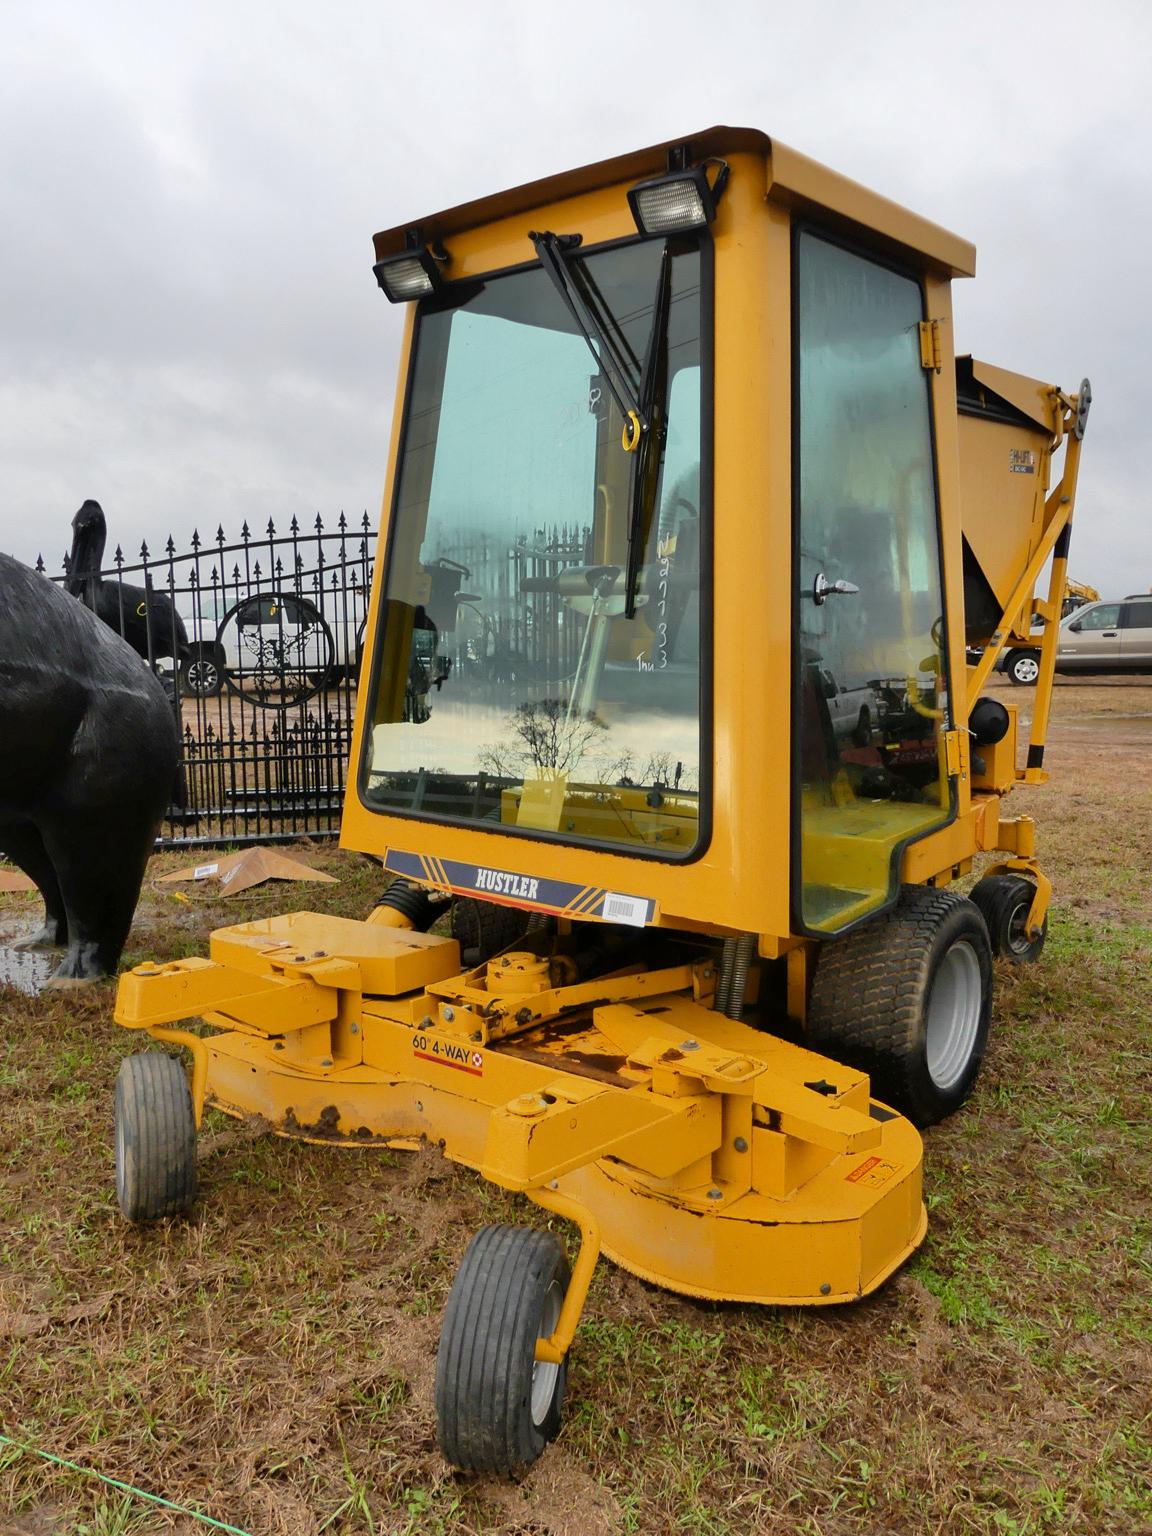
[117, 127, 1089, 1473]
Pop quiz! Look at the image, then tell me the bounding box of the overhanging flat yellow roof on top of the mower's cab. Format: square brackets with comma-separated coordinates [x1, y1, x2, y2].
[373, 127, 975, 276]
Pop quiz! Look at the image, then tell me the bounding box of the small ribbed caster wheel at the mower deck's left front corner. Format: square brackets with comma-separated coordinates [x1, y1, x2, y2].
[117, 1051, 197, 1221]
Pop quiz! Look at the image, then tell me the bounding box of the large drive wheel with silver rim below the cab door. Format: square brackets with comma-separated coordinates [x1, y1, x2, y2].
[805, 886, 992, 1126]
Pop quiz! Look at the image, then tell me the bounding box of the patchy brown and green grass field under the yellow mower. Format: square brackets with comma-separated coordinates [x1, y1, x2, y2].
[0, 682, 1152, 1536]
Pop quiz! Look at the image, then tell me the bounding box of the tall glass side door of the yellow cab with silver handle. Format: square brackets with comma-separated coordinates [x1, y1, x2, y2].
[793, 229, 951, 934]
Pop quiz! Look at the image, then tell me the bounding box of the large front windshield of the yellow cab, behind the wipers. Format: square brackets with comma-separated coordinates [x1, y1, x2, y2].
[361, 240, 703, 857]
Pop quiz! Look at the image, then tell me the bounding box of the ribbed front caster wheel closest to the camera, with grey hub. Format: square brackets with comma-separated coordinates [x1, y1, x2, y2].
[436, 1226, 570, 1476]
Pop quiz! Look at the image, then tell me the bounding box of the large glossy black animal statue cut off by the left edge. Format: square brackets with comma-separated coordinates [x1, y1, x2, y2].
[0, 554, 180, 985]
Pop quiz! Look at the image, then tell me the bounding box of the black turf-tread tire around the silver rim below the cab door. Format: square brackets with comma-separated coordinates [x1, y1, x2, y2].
[805, 885, 992, 1127]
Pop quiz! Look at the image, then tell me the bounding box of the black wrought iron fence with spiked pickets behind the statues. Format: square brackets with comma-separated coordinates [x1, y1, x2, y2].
[37, 513, 375, 848]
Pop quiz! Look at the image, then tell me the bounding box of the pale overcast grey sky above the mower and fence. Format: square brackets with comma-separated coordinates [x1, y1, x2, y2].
[0, 0, 1152, 596]
